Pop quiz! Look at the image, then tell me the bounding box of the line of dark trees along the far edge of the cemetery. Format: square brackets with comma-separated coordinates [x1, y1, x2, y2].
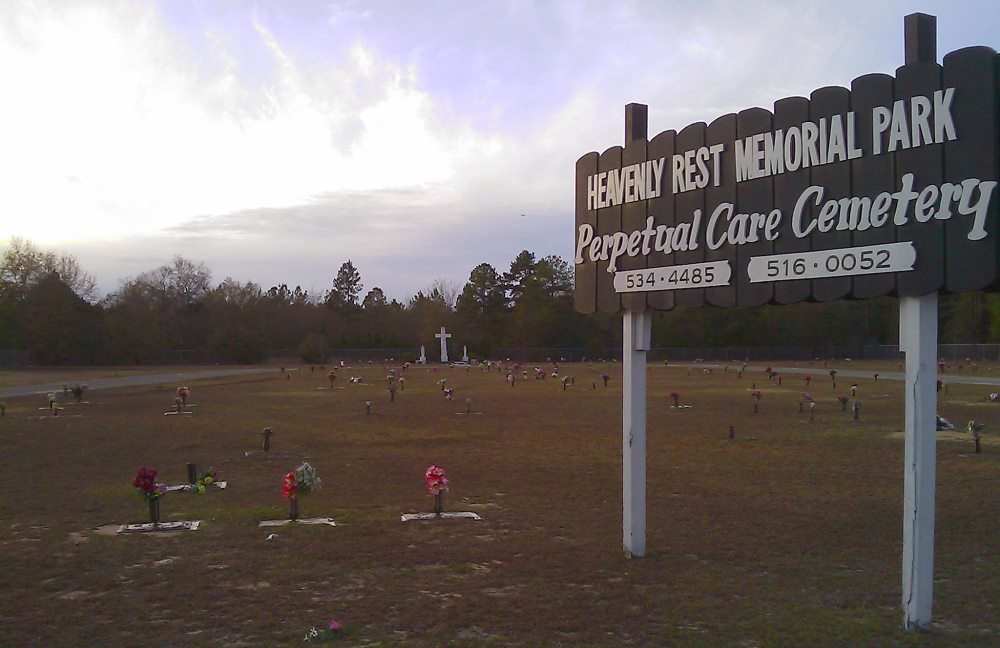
[0, 238, 1000, 364]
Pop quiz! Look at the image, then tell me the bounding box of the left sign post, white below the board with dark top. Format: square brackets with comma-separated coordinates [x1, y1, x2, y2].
[622, 103, 653, 558]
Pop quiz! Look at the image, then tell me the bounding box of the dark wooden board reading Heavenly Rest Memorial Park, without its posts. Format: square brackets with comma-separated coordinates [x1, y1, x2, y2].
[574, 47, 1000, 313]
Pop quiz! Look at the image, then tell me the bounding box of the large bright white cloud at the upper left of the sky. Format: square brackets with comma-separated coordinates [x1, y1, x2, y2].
[0, 0, 496, 244]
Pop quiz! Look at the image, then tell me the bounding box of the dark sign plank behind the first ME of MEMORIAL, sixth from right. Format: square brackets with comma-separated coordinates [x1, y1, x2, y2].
[733, 108, 774, 306]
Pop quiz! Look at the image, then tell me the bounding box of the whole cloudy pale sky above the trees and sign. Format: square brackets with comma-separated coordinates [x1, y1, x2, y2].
[0, 0, 1000, 302]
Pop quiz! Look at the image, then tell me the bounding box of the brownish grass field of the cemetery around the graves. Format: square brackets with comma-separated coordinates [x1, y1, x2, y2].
[0, 362, 1000, 646]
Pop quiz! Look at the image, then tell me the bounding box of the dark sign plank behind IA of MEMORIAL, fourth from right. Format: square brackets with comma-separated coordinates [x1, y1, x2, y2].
[809, 86, 851, 301]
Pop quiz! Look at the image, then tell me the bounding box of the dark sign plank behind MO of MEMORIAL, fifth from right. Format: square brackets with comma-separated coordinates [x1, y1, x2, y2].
[774, 97, 812, 304]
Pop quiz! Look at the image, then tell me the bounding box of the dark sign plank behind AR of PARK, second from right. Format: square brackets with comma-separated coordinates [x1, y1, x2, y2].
[895, 62, 944, 297]
